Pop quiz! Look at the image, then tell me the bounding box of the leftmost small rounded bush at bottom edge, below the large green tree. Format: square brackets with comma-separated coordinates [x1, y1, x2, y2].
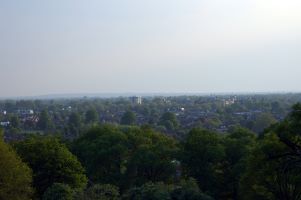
[43, 183, 74, 200]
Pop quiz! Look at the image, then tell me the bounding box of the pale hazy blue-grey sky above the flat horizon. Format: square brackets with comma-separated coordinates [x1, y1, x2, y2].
[0, 0, 301, 97]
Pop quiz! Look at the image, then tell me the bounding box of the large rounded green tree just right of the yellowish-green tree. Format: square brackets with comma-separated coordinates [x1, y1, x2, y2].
[15, 137, 87, 197]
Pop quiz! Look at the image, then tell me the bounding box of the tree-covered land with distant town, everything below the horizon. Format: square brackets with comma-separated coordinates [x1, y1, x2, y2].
[0, 94, 301, 200]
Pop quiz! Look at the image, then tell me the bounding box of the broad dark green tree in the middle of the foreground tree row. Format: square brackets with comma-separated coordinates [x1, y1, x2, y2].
[126, 128, 179, 185]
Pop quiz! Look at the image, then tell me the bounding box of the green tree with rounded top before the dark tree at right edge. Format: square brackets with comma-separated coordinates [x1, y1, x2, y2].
[241, 135, 285, 199]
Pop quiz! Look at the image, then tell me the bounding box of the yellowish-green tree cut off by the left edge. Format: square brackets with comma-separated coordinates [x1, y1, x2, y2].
[0, 130, 33, 200]
